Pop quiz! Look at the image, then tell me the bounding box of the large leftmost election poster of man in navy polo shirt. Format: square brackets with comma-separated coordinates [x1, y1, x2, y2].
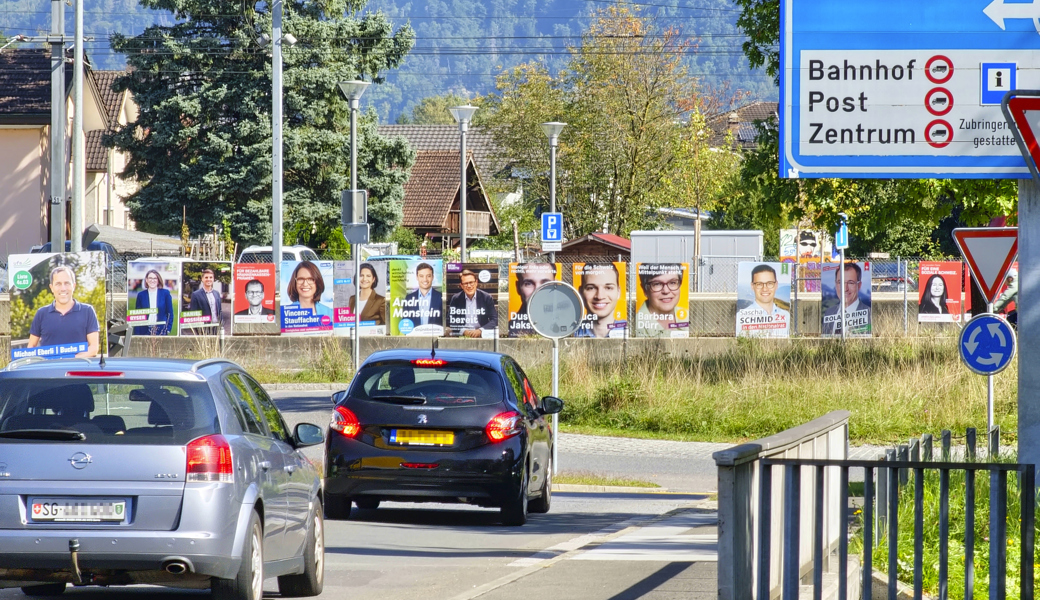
[7, 252, 107, 360]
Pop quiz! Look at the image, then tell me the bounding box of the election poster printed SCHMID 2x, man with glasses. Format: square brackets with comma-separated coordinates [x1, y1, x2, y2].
[736, 262, 791, 338]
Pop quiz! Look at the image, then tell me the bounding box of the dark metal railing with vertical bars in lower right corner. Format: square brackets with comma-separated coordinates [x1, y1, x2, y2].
[755, 429, 1036, 600]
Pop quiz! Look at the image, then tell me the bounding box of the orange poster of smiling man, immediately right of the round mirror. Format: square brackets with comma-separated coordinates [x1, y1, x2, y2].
[572, 262, 628, 338]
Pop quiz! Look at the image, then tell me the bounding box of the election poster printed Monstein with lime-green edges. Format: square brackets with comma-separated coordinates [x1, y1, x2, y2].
[388, 260, 444, 337]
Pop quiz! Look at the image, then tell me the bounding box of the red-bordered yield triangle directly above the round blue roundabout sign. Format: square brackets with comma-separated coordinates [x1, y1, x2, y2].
[954, 227, 1018, 303]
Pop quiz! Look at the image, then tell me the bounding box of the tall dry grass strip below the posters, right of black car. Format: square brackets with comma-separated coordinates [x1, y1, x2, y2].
[530, 338, 1017, 443]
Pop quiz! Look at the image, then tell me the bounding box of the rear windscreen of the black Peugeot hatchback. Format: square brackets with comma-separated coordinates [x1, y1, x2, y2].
[349, 361, 504, 407]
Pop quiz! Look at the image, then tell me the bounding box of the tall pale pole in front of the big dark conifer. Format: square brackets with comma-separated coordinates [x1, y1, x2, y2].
[257, 0, 296, 293]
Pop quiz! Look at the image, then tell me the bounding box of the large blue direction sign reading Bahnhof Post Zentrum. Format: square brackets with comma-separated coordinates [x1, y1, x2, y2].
[779, 0, 1040, 179]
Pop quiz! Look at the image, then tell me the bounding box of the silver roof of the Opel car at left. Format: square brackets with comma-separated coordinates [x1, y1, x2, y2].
[0, 357, 241, 383]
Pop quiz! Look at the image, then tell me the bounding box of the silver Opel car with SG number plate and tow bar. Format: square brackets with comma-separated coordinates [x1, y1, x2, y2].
[0, 359, 324, 600]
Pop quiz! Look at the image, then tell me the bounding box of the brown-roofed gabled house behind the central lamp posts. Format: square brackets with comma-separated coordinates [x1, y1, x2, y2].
[379, 125, 509, 243]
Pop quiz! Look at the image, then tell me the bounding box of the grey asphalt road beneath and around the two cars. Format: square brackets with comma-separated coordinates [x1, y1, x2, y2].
[0, 391, 717, 600]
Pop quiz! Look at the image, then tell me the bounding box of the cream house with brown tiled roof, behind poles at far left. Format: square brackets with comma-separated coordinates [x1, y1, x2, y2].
[0, 48, 136, 255]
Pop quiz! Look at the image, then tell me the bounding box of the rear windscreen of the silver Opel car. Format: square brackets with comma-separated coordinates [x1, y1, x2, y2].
[0, 379, 219, 445]
